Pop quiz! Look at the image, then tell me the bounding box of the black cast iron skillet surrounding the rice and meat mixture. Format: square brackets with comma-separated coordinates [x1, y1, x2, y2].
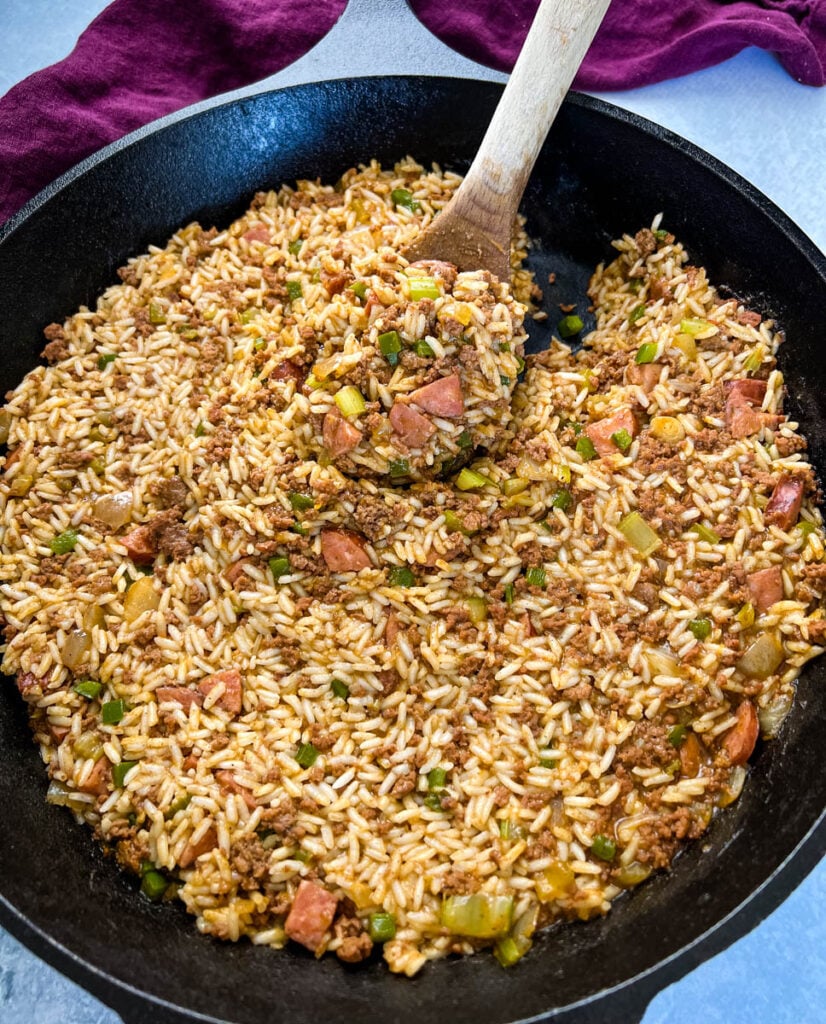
[0, 77, 826, 1024]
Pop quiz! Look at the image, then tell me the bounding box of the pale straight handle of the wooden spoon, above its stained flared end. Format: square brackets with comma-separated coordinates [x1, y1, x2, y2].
[462, 0, 610, 237]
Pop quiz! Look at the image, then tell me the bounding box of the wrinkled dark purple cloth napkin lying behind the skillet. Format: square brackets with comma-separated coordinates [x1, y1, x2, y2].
[0, 0, 826, 223]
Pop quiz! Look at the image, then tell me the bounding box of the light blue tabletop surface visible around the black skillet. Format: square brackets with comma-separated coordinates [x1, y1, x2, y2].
[0, 0, 826, 1024]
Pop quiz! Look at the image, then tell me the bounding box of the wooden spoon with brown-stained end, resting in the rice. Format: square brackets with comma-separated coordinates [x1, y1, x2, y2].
[404, 0, 610, 281]
